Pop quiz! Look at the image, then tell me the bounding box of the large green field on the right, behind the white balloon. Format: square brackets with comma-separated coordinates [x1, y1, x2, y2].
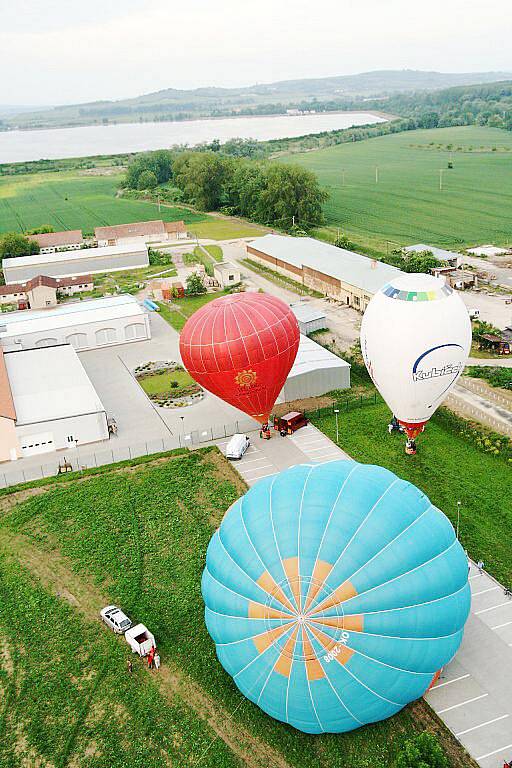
[289, 126, 512, 249]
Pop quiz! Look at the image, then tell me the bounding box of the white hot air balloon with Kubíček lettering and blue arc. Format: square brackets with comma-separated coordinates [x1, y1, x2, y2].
[361, 274, 471, 452]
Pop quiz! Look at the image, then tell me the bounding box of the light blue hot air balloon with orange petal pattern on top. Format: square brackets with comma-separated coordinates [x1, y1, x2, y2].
[202, 461, 470, 733]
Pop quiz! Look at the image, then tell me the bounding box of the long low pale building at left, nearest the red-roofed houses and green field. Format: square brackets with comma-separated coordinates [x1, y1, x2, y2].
[2, 244, 149, 285]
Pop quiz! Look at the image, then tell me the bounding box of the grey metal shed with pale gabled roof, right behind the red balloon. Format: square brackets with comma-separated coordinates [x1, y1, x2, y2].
[278, 334, 350, 403]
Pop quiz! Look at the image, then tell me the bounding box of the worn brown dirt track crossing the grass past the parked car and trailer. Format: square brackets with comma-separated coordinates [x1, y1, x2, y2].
[0, 532, 291, 768]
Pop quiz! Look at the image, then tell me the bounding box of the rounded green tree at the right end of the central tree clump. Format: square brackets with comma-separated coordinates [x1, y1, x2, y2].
[256, 163, 328, 229]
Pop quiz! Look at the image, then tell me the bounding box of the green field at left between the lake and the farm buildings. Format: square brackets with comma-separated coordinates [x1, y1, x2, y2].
[0, 169, 264, 240]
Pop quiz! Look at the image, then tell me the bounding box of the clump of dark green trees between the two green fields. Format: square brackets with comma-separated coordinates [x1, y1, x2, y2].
[124, 149, 327, 231]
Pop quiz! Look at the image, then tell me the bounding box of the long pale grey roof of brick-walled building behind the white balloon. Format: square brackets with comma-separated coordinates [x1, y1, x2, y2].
[249, 235, 404, 293]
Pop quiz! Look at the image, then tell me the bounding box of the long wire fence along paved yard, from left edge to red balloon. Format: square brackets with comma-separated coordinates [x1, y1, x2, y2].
[0, 418, 258, 488]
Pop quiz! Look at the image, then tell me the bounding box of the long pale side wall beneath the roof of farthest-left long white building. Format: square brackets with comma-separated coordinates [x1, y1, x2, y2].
[3, 248, 149, 284]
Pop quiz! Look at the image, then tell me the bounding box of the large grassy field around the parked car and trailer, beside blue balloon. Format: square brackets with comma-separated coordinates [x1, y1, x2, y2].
[0, 449, 467, 768]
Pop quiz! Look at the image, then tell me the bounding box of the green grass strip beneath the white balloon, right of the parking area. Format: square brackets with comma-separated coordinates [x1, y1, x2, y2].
[312, 404, 512, 587]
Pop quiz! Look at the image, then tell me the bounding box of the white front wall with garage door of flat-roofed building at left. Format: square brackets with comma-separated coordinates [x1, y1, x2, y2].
[16, 411, 109, 459]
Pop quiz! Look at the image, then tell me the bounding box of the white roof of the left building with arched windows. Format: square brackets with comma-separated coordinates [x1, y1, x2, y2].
[0, 294, 145, 339]
